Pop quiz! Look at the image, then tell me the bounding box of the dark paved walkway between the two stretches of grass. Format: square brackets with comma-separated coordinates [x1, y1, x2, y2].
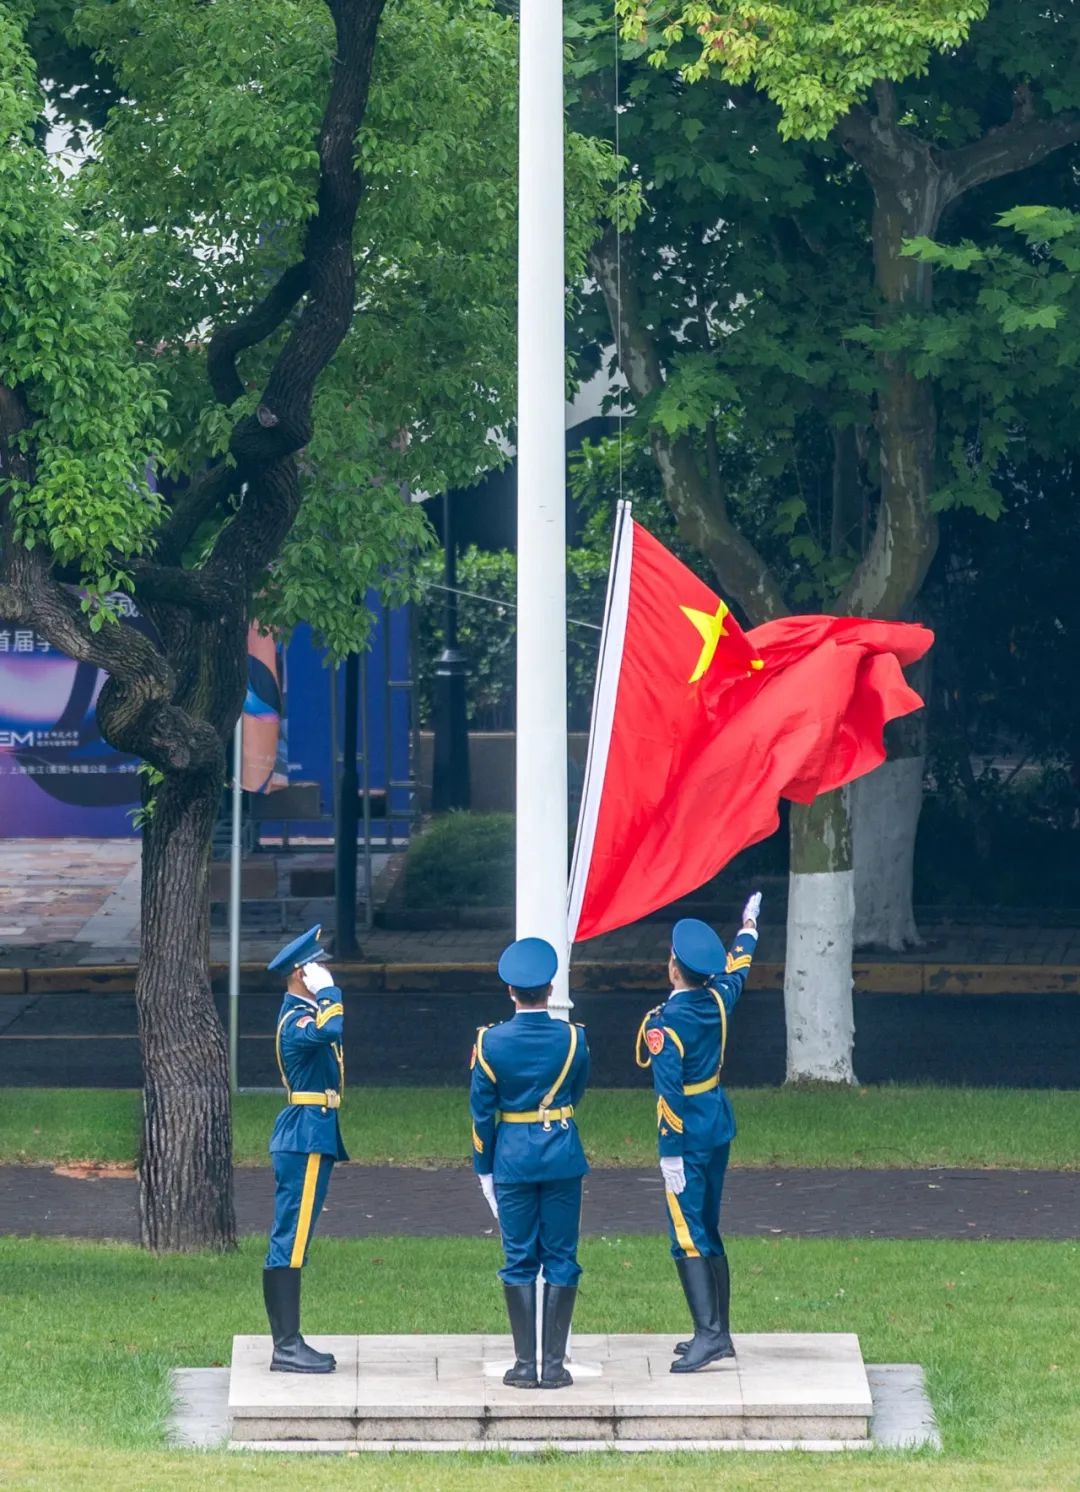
[0, 1165, 1080, 1240]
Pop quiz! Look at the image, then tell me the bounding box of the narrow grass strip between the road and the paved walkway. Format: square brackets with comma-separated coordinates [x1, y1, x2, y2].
[0, 1086, 1080, 1170]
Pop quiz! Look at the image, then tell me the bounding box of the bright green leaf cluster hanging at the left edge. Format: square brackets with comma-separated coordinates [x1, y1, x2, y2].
[0, 15, 161, 592]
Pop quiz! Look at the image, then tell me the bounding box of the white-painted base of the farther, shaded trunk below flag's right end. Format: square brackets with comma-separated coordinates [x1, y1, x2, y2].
[850, 756, 925, 953]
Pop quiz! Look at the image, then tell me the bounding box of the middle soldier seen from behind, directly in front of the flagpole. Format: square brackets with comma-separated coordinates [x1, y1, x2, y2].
[470, 937, 589, 1389]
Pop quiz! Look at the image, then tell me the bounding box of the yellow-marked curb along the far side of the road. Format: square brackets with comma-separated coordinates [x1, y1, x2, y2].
[0, 959, 1080, 995]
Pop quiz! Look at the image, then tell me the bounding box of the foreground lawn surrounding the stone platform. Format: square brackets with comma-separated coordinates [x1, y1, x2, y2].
[0, 1238, 1080, 1492]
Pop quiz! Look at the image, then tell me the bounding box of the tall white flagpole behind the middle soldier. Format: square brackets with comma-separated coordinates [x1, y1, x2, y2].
[516, 0, 571, 1021]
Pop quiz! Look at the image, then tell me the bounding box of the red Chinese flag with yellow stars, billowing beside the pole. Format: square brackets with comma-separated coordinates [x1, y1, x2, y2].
[570, 510, 934, 941]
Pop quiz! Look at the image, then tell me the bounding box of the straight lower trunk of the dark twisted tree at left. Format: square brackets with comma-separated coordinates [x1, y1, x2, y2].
[136, 771, 236, 1250]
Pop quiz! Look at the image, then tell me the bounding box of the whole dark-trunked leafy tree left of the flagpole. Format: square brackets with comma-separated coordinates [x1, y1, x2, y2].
[0, 0, 610, 1247]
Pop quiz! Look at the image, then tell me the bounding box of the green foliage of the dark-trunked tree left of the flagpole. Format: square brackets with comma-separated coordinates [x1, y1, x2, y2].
[0, 0, 611, 655]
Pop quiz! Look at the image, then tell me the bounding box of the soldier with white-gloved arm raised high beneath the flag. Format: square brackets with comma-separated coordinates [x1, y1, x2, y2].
[635, 892, 761, 1373]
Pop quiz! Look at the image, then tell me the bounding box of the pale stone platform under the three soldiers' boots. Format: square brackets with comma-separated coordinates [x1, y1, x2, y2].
[228, 1332, 873, 1450]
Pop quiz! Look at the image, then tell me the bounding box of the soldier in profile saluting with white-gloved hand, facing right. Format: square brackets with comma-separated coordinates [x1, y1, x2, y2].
[263, 927, 349, 1373]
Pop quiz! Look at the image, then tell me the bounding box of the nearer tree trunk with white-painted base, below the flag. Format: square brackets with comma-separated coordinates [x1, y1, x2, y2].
[783, 789, 855, 1083]
